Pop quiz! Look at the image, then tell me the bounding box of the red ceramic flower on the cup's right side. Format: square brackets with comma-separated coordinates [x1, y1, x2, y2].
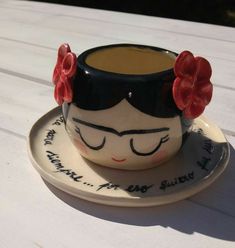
[173, 51, 213, 119]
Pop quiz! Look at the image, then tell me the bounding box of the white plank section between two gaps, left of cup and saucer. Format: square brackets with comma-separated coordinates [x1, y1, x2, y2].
[0, 73, 57, 136]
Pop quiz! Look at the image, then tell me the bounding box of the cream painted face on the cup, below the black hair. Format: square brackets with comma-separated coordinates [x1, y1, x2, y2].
[66, 100, 182, 170]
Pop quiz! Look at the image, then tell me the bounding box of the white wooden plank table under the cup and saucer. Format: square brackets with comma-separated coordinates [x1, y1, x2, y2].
[0, 0, 235, 248]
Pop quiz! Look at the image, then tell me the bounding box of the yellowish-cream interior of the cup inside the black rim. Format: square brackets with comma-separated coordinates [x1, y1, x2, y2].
[85, 46, 175, 75]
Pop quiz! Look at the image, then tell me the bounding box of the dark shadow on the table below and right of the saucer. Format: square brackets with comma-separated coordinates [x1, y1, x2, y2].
[44, 142, 235, 241]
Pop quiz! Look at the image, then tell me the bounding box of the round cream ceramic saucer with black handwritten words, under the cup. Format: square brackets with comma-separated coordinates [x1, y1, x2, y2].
[28, 107, 229, 207]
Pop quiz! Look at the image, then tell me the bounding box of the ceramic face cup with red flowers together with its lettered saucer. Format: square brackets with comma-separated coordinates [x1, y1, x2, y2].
[28, 44, 230, 207]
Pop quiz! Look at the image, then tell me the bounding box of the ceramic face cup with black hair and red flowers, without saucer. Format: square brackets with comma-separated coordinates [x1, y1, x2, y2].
[53, 44, 212, 170]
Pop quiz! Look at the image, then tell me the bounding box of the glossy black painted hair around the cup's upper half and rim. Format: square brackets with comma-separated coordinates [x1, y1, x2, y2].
[72, 44, 182, 118]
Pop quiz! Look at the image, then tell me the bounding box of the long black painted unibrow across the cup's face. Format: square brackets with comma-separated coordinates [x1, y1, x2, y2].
[73, 117, 170, 136]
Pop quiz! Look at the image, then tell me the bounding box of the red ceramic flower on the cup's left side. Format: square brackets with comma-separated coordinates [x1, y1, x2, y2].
[52, 44, 77, 105]
